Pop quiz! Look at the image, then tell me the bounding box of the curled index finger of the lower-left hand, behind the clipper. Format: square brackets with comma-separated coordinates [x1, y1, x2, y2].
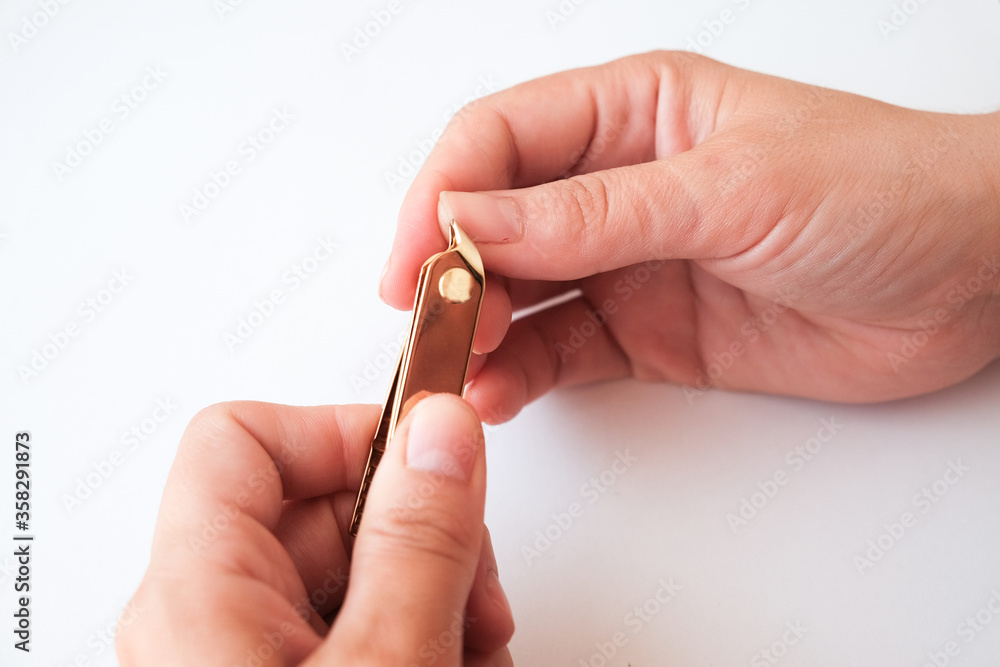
[153, 401, 378, 557]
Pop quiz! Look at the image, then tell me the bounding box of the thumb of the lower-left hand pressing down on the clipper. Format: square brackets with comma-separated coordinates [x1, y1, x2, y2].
[320, 394, 486, 665]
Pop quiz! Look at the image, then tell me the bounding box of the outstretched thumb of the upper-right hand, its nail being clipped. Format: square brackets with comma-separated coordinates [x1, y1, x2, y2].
[438, 150, 766, 280]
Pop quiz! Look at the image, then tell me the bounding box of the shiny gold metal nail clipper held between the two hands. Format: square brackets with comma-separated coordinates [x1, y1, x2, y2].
[351, 220, 486, 535]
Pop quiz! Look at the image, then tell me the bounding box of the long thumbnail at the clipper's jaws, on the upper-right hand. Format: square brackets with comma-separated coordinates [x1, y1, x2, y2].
[438, 192, 524, 243]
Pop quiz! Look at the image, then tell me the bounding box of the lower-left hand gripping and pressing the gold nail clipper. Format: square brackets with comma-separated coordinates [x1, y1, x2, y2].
[117, 395, 513, 667]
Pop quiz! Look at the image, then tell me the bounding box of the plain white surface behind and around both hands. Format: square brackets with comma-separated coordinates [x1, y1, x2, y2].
[0, 0, 1000, 667]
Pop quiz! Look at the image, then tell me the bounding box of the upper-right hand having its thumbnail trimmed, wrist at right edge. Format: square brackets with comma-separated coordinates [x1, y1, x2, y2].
[380, 52, 1000, 421]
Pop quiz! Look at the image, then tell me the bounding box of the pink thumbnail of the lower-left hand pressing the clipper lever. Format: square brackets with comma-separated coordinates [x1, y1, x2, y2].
[406, 394, 482, 481]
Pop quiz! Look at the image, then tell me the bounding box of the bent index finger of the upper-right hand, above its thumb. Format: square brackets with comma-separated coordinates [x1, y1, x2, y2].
[380, 54, 689, 309]
